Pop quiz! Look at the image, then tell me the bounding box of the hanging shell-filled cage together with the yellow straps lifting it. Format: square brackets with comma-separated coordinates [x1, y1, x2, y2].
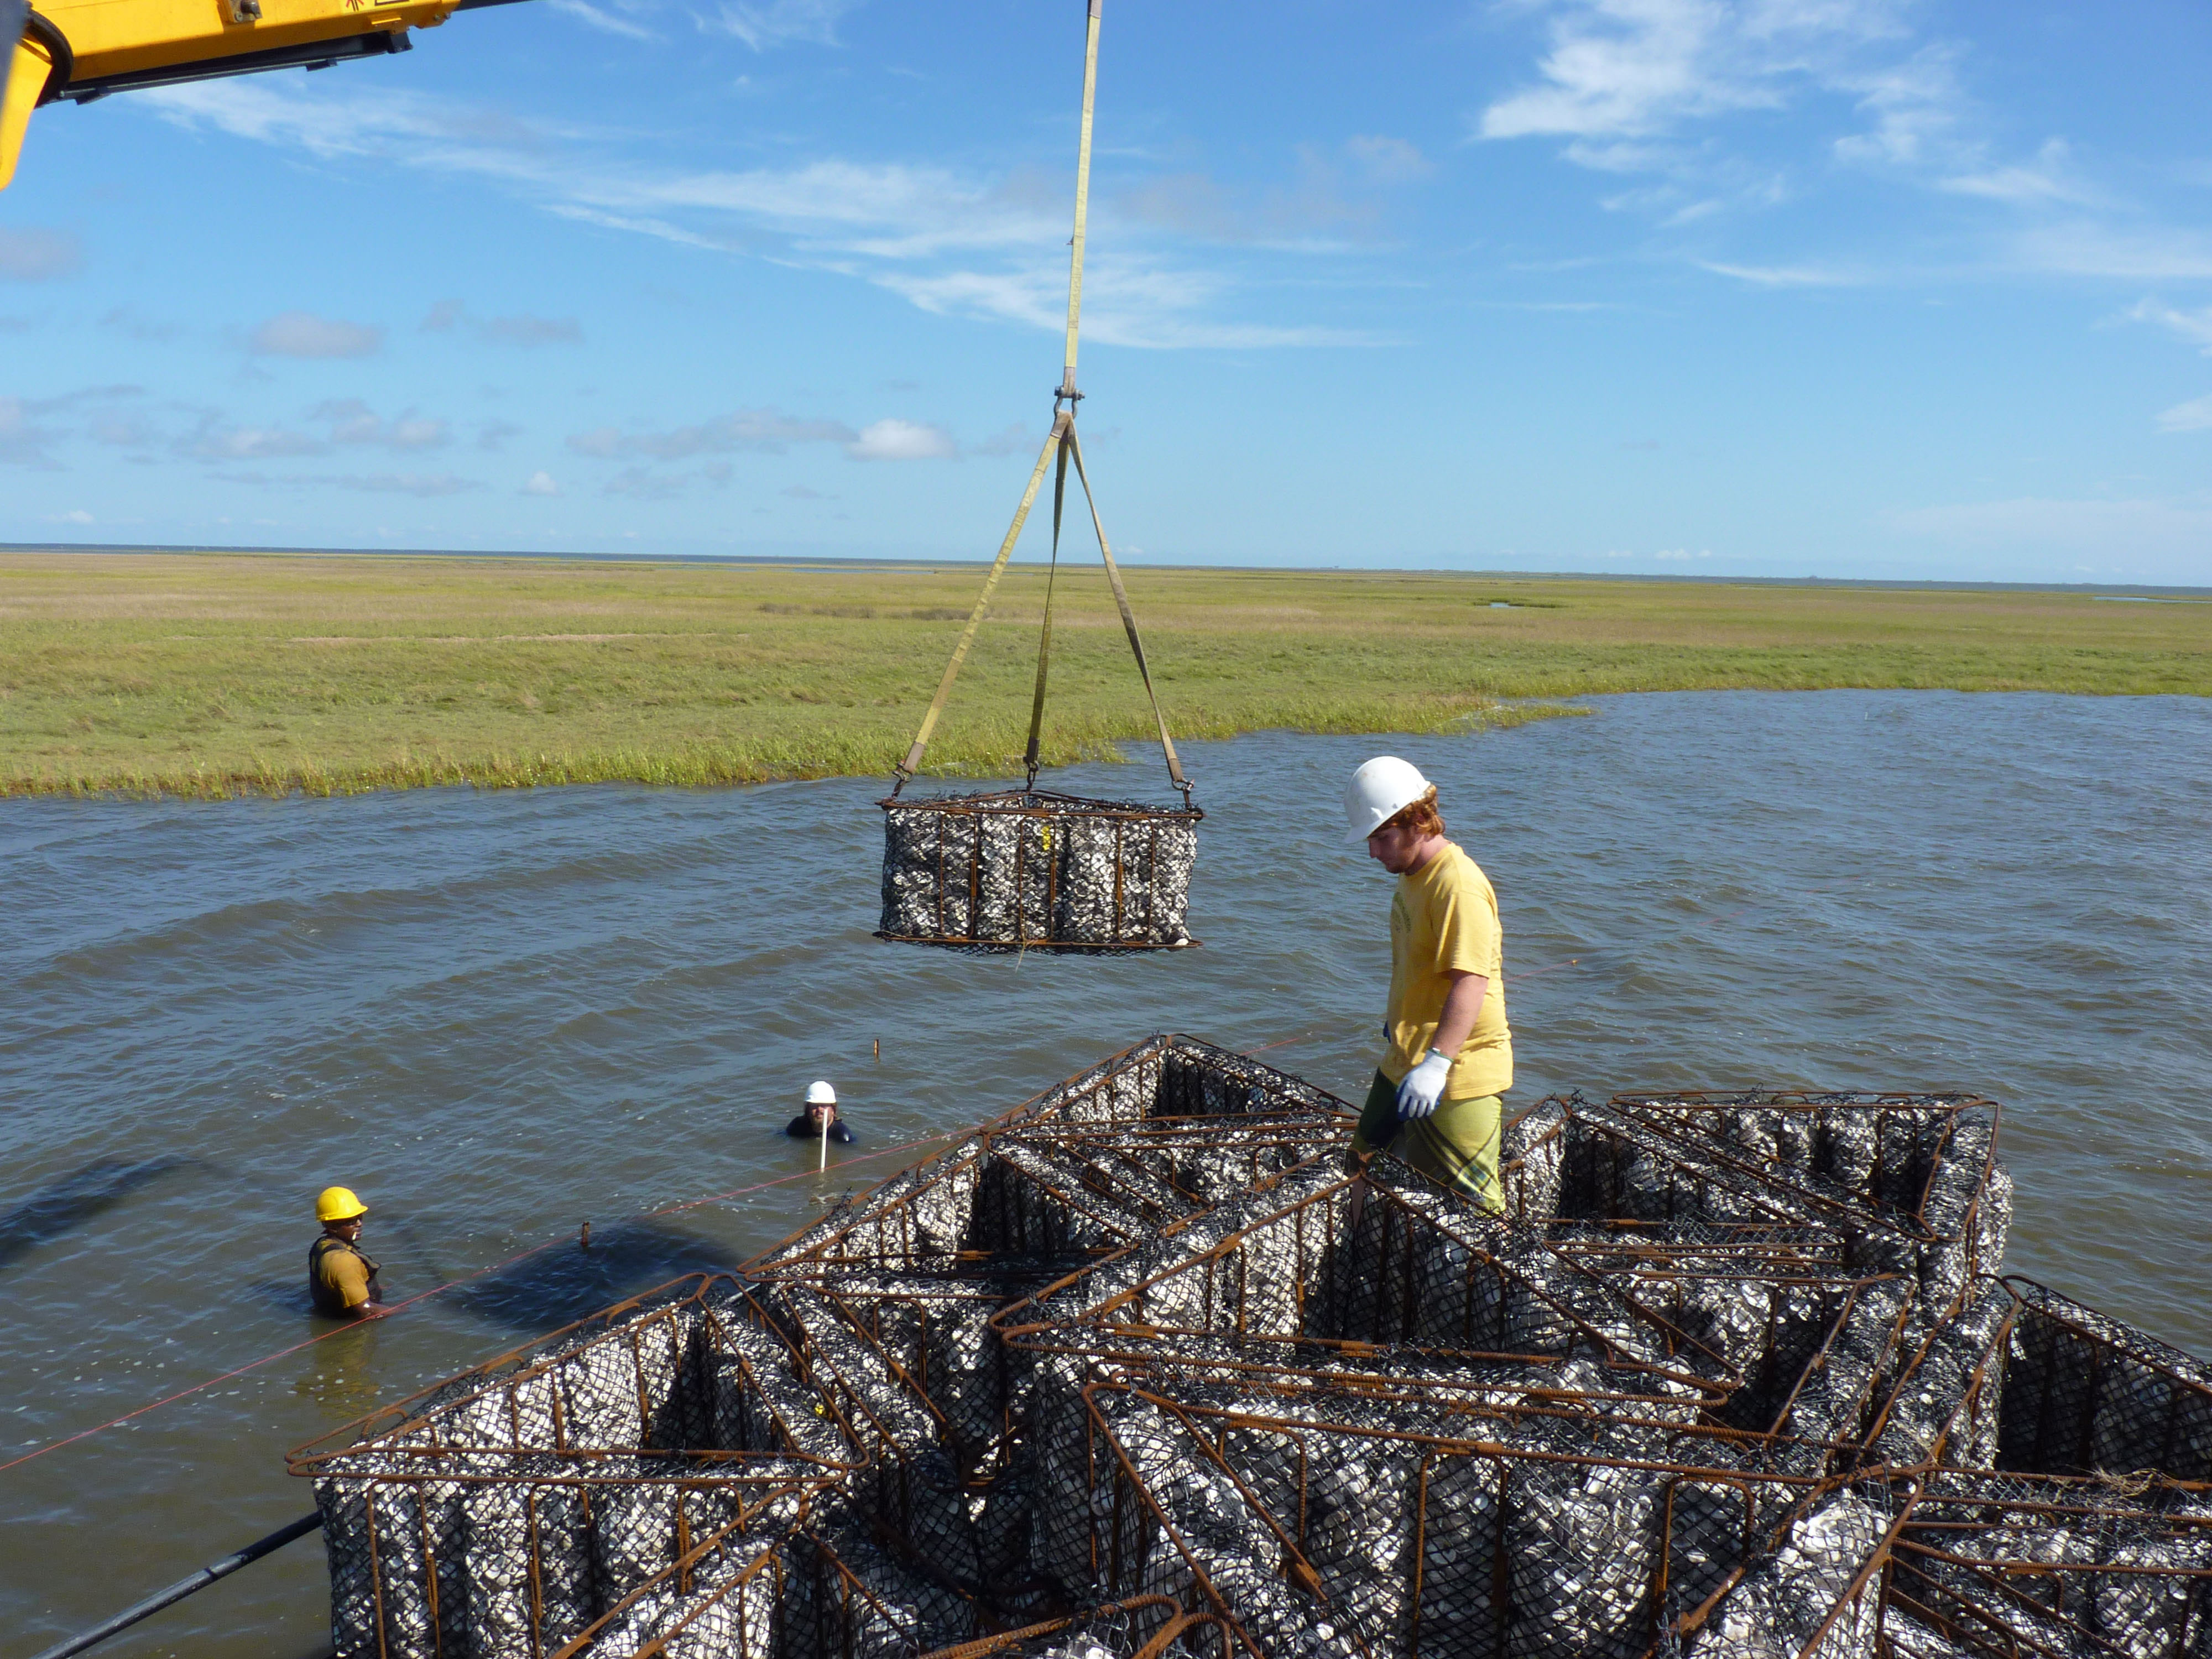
[876, 7, 1206, 956]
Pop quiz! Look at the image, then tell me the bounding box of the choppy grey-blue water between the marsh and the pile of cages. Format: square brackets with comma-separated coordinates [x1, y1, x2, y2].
[0, 692, 2212, 1659]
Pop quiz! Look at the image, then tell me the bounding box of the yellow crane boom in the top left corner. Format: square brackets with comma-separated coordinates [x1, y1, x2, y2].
[0, 0, 518, 190]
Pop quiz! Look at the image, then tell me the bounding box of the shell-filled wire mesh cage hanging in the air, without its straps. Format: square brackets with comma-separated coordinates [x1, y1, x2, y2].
[876, 790, 1206, 953]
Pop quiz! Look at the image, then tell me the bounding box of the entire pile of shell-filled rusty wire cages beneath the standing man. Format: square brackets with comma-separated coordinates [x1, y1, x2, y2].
[294, 1035, 2212, 1659]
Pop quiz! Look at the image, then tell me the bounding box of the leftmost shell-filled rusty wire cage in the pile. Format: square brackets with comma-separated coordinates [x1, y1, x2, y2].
[290, 1276, 865, 1659]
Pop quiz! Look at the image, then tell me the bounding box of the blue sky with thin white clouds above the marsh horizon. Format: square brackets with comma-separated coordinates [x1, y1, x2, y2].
[0, 0, 2212, 584]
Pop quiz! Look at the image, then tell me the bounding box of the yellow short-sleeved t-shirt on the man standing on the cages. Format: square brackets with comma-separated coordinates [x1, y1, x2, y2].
[1383, 841, 1513, 1099]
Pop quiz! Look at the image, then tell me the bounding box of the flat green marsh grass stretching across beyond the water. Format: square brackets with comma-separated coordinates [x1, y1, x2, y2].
[0, 553, 2212, 796]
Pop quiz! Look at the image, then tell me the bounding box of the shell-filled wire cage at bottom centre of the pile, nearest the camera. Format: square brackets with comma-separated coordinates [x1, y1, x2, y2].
[1071, 1383, 1885, 1657]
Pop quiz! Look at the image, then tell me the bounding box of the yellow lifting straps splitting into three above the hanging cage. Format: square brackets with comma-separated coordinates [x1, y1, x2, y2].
[891, 0, 1190, 803]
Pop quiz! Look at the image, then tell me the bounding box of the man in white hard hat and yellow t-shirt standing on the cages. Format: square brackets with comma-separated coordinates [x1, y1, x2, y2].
[1345, 754, 1513, 1212]
